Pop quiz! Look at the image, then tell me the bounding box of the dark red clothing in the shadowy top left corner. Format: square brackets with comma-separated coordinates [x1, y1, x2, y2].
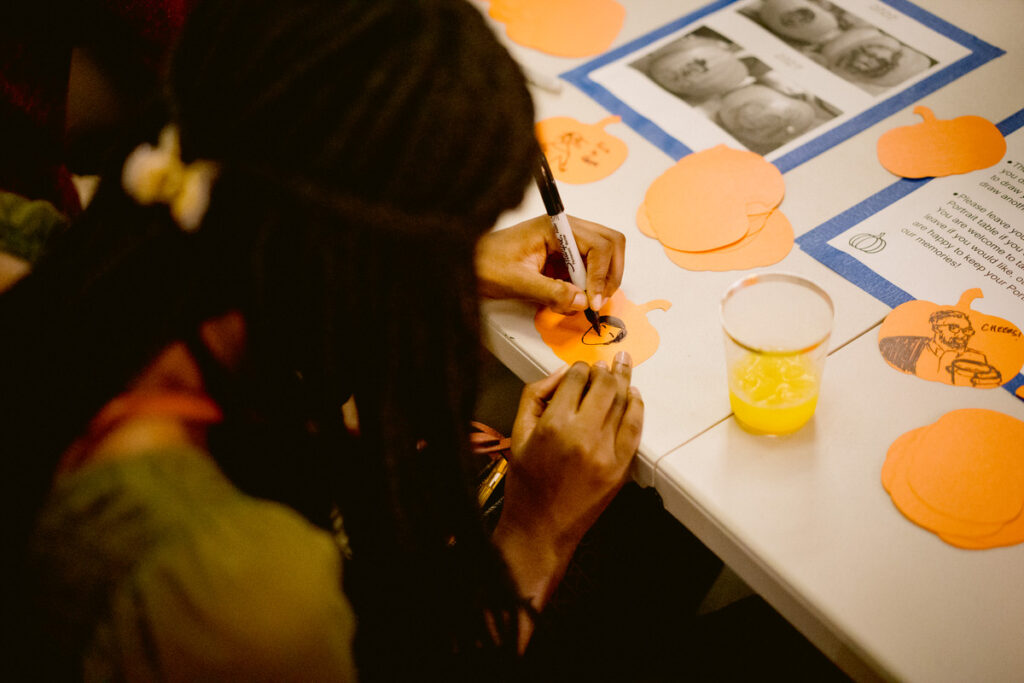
[0, 0, 195, 215]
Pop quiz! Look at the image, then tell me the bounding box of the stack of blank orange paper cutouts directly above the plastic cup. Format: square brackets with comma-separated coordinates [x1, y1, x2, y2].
[637, 144, 794, 270]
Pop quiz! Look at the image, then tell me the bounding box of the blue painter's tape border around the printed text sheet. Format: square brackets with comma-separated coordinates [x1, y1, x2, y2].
[796, 109, 1024, 401]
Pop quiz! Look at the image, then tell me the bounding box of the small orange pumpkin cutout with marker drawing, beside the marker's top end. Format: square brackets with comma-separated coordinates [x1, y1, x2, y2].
[536, 116, 629, 184]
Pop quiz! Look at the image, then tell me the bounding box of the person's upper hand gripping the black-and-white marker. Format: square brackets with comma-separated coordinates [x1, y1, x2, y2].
[476, 216, 626, 314]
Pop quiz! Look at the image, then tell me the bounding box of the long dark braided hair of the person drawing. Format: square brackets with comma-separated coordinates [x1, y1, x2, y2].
[0, 0, 536, 680]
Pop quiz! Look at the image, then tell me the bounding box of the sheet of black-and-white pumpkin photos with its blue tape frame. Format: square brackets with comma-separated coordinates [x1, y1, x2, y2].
[563, 0, 973, 163]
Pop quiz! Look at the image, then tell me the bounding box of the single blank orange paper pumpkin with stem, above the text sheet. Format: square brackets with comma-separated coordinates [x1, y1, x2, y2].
[878, 105, 1007, 178]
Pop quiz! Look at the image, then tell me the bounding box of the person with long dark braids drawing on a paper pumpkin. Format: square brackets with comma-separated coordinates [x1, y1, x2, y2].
[0, 0, 643, 681]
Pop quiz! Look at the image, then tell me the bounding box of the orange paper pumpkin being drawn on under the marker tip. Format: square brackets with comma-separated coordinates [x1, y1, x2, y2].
[534, 291, 672, 367]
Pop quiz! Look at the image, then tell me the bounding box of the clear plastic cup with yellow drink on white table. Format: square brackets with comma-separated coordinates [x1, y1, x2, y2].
[721, 272, 835, 434]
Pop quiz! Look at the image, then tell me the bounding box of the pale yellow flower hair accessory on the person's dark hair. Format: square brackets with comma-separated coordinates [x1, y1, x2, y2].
[121, 124, 220, 232]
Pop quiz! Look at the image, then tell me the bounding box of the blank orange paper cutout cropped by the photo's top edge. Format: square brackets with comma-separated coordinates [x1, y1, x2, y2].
[488, 0, 626, 57]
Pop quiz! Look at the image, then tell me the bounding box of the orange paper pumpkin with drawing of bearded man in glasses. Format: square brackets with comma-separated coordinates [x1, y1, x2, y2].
[879, 288, 1024, 388]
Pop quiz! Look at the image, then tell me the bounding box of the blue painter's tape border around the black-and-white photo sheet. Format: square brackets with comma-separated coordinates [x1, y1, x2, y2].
[561, 0, 1005, 173]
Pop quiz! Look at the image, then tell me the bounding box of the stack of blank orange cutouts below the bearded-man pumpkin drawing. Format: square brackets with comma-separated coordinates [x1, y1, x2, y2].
[882, 409, 1024, 549]
